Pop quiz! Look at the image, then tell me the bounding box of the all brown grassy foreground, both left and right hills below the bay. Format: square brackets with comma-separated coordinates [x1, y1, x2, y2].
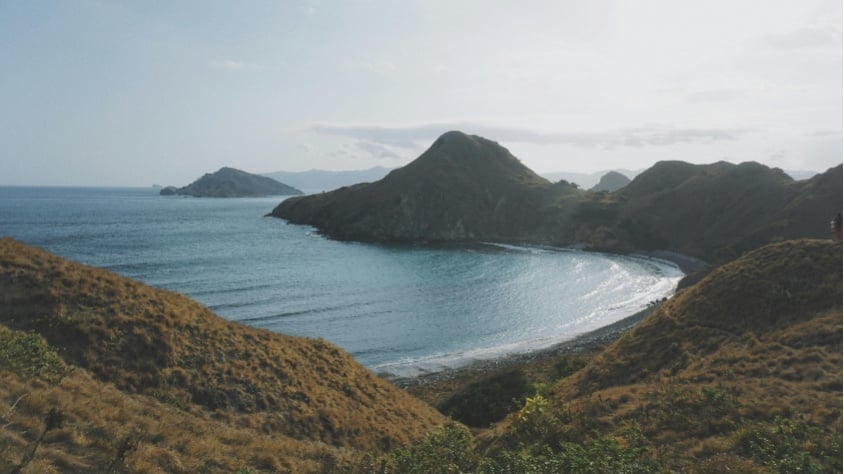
[0, 240, 842, 473]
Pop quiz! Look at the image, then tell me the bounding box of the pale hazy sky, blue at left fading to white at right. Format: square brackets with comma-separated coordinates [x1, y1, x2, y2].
[0, 0, 844, 186]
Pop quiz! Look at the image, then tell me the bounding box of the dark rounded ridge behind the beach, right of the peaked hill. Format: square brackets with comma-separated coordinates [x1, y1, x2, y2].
[610, 162, 842, 261]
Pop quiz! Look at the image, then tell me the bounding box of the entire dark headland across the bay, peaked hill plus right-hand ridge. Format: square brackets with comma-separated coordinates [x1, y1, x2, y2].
[271, 131, 842, 262]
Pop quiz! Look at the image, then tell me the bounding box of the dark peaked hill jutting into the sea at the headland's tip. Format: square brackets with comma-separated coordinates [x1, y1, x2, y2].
[271, 132, 568, 241]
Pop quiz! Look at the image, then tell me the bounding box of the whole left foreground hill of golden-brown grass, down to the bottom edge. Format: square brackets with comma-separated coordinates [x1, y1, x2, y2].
[0, 239, 446, 472]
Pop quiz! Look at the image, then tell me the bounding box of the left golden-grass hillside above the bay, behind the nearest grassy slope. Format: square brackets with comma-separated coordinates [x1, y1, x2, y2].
[0, 239, 445, 458]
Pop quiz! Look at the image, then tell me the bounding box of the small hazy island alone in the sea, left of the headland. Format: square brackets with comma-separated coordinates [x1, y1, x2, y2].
[159, 167, 302, 198]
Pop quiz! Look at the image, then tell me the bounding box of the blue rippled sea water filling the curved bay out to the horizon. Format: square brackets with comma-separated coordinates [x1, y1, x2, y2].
[0, 187, 682, 376]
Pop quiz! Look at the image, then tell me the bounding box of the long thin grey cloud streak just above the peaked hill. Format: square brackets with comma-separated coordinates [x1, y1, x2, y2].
[311, 122, 752, 149]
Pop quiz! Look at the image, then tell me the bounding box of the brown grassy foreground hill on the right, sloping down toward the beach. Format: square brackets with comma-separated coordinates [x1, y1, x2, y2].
[481, 240, 842, 473]
